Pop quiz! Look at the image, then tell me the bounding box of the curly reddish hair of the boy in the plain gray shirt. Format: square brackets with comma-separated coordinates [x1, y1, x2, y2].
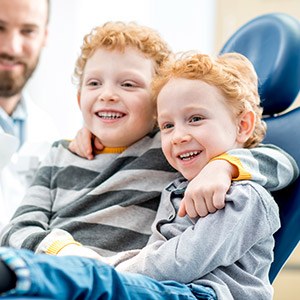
[152, 53, 266, 148]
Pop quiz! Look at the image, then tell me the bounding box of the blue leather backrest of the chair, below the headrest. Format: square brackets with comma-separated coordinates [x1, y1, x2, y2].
[264, 108, 300, 282]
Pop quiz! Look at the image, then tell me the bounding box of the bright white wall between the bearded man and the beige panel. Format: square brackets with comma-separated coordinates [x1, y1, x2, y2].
[27, 0, 215, 138]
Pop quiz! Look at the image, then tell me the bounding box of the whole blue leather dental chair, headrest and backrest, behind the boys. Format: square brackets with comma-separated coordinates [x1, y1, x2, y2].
[221, 13, 300, 282]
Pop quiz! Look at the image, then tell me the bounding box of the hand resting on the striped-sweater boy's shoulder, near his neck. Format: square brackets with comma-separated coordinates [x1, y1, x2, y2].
[69, 127, 104, 159]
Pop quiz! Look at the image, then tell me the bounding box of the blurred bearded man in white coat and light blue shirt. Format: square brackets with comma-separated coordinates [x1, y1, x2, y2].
[0, 0, 57, 227]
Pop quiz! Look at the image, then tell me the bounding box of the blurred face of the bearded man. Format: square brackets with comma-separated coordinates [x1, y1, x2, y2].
[0, 0, 48, 98]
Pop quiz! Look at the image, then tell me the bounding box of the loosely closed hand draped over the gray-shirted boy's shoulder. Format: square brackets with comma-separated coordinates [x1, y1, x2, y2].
[178, 160, 237, 218]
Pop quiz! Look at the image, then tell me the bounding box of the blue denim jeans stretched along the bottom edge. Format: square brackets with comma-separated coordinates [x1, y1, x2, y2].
[0, 249, 217, 300]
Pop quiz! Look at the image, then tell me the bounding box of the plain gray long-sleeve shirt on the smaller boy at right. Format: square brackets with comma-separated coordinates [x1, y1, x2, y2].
[111, 180, 280, 300]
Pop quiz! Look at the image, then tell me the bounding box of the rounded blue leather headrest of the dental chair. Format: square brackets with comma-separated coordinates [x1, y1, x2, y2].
[221, 13, 300, 115]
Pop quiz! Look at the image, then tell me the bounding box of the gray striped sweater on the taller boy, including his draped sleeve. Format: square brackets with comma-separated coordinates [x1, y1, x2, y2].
[1, 133, 296, 256]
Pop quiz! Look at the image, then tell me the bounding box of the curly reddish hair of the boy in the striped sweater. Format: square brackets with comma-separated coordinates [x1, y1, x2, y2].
[73, 22, 171, 88]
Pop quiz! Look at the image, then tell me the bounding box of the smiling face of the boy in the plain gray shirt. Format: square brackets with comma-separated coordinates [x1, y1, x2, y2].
[157, 78, 242, 180]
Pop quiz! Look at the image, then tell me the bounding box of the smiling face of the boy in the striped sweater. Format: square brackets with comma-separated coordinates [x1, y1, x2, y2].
[78, 48, 155, 147]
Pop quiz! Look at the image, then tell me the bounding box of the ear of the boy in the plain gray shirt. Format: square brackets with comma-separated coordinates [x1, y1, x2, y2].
[237, 110, 255, 144]
